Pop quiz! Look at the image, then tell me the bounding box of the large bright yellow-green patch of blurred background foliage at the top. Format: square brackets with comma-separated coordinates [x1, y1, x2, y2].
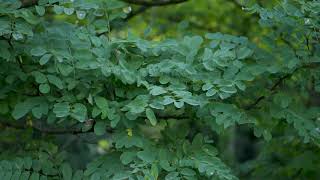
[126, 0, 273, 38]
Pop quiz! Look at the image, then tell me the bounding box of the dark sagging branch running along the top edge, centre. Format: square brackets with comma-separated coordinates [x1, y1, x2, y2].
[122, 0, 188, 6]
